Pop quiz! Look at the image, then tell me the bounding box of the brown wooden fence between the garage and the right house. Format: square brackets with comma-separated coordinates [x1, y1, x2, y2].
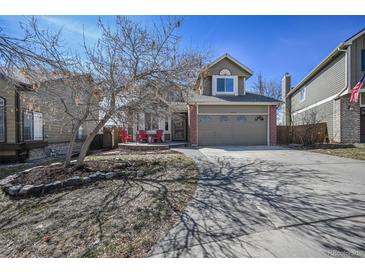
[277, 123, 328, 145]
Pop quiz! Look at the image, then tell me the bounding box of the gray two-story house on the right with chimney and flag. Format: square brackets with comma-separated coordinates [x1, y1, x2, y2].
[282, 29, 365, 143]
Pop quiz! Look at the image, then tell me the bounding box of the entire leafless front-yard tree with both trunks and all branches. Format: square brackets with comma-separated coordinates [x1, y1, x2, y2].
[0, 16, 202, 167]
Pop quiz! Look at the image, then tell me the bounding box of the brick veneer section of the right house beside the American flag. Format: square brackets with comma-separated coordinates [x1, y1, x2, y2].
[339, 94, 360, 143]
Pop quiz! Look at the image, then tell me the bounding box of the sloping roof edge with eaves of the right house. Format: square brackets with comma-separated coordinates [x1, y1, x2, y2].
[287, 28, 365, 97]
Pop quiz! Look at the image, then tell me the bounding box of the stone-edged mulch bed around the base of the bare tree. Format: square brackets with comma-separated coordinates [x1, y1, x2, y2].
[12, 160, 146, 185]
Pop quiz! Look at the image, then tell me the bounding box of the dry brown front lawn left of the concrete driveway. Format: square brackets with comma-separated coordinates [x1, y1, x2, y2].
[0, 148, 198, 257]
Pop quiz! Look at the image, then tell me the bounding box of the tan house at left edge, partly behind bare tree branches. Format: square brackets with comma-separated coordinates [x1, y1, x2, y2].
[0, 71, 93, 163]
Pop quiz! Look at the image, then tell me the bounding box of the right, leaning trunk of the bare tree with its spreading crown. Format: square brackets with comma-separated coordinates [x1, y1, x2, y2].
[77, 16, 201, 166]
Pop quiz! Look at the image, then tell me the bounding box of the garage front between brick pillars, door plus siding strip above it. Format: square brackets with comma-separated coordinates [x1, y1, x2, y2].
[197, 105, 269, 145]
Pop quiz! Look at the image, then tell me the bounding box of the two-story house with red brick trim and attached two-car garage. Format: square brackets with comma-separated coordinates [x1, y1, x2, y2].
[122, 54, 280, 145]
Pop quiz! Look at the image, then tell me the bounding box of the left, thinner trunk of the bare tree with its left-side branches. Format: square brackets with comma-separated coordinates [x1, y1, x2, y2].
[0, 18, 99, 165]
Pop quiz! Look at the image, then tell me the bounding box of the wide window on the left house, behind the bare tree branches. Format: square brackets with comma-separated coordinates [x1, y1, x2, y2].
[23, 111, 43, 141]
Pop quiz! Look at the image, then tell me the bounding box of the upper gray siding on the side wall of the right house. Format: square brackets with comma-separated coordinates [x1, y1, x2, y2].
[291, 54, 346, 113]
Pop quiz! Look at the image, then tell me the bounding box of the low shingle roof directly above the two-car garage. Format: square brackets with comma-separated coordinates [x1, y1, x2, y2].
[191, 92, 281, 104]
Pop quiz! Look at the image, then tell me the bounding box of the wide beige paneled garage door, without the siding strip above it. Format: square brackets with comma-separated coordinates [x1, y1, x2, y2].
[198, 114, 267, 145]
